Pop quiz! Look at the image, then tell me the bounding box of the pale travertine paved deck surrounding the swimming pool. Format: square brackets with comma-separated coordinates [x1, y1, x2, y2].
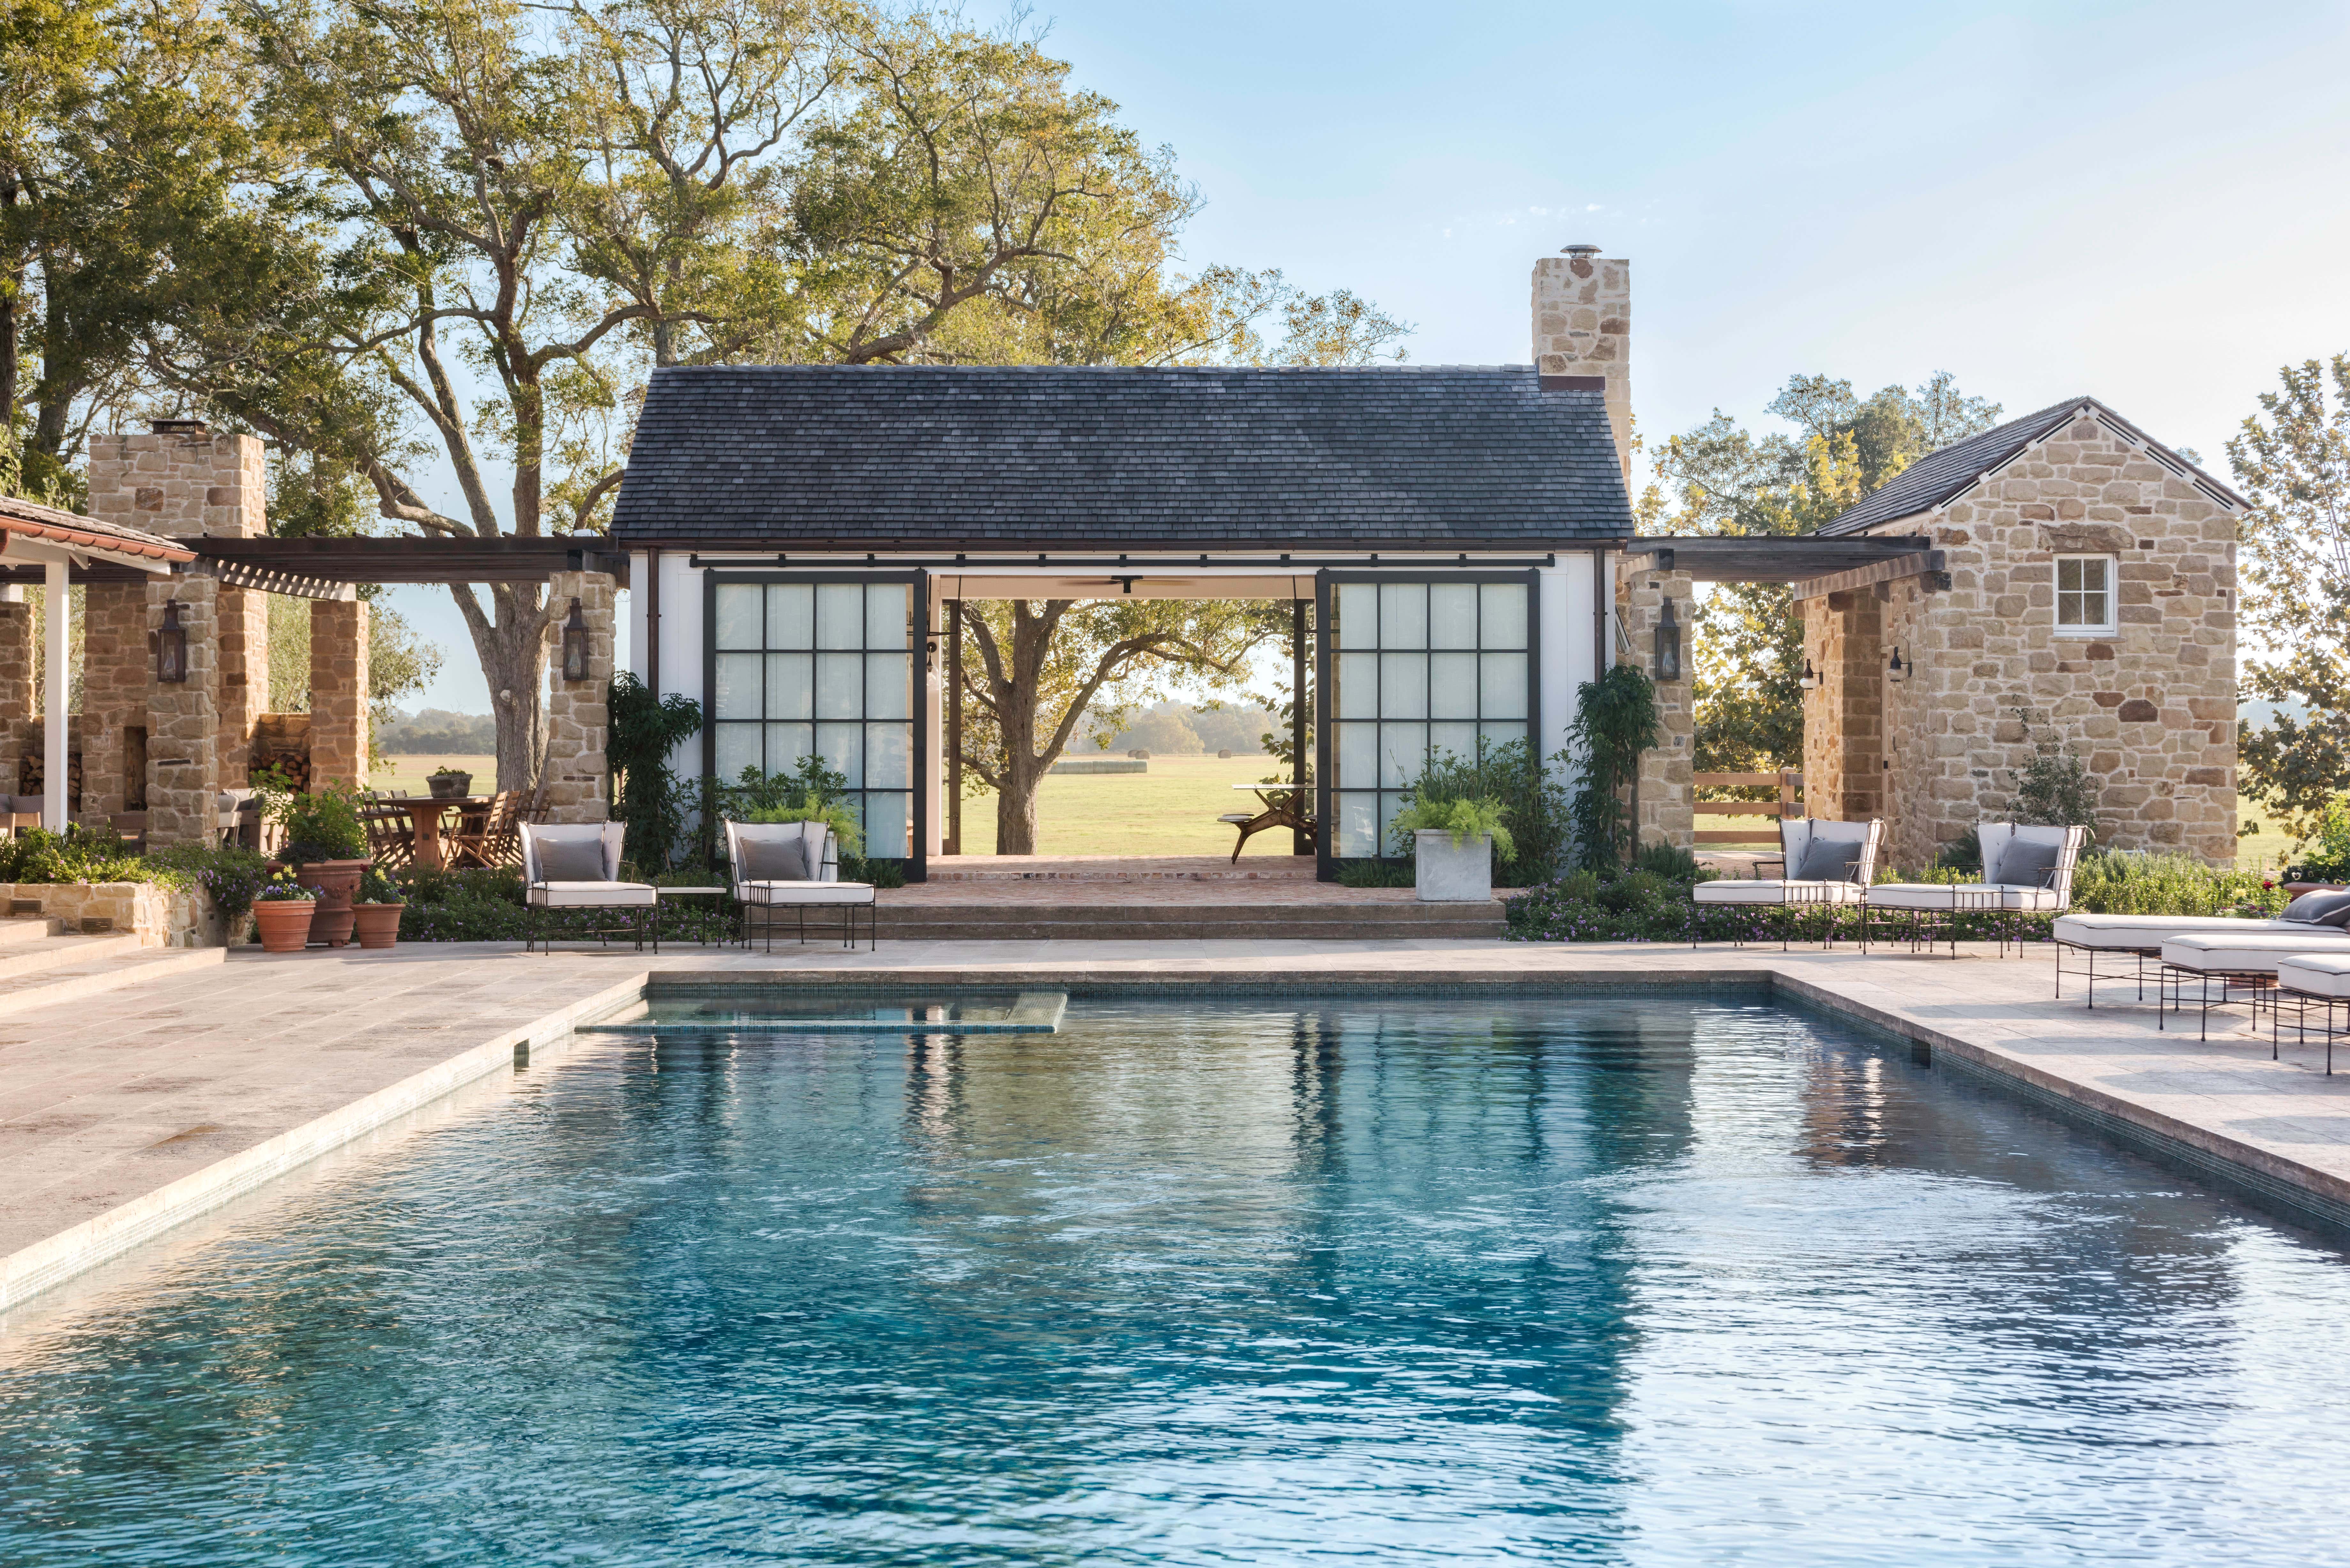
[0, 938, 2350, 1309]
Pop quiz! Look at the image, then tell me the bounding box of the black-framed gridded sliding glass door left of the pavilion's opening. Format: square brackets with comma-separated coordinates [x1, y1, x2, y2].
[703, 571, 928, 877]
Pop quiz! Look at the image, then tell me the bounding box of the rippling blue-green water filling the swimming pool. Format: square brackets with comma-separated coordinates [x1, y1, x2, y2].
[0, 997, 2350, 1568]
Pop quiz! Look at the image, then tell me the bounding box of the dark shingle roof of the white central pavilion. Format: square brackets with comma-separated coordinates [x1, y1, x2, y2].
[613, 367, 1631, 550]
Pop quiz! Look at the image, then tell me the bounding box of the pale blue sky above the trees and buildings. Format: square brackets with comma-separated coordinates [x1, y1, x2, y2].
[381, 0, 2350, 712]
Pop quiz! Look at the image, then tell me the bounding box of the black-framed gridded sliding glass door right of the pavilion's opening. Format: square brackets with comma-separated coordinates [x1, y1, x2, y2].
[1318, 571, 1542, 877]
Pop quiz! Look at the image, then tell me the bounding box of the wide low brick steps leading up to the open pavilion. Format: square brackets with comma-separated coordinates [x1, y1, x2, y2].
[865, 896, 1509, 943]
